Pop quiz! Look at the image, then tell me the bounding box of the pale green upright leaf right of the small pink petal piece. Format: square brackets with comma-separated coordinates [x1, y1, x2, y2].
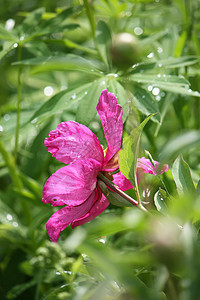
[172, 155, 195, 195]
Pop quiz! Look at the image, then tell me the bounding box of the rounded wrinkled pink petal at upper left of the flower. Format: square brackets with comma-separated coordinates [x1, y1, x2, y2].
[44, 121, 104, 164]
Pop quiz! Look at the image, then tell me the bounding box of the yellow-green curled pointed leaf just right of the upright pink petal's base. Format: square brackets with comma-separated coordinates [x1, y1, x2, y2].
[119, 115, 155, 187]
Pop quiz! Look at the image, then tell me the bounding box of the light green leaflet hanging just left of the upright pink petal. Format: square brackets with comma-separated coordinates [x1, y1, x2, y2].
[76, 79, 105, 126]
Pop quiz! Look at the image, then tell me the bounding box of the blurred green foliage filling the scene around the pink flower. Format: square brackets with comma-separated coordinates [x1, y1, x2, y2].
[0, 0, 200, 300]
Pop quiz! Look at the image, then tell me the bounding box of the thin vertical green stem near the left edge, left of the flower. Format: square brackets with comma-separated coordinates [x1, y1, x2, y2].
[14, 44, 22, 161]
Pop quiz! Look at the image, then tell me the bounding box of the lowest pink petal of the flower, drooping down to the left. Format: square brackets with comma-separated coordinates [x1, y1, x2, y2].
[46, 189, 96, 242]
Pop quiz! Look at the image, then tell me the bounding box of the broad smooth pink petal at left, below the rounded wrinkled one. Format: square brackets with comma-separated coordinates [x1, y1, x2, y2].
[42, 159, 101, 206]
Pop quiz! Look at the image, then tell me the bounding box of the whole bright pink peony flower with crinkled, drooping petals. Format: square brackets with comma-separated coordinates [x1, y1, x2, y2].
[42, 90, 167, 242]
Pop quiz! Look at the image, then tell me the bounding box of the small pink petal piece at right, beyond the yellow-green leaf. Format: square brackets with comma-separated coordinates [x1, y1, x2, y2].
[137, 157, 169, 175]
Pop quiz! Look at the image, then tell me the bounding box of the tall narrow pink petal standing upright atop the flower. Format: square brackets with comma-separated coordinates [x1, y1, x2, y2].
[97, 90, 123, 164]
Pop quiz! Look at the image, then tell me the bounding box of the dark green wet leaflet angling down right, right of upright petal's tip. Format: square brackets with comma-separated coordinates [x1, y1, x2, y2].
[131, 84, 160, 123]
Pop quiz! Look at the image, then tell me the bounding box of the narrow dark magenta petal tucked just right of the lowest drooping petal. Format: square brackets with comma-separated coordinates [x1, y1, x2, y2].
[71, 185, 110, 228]
